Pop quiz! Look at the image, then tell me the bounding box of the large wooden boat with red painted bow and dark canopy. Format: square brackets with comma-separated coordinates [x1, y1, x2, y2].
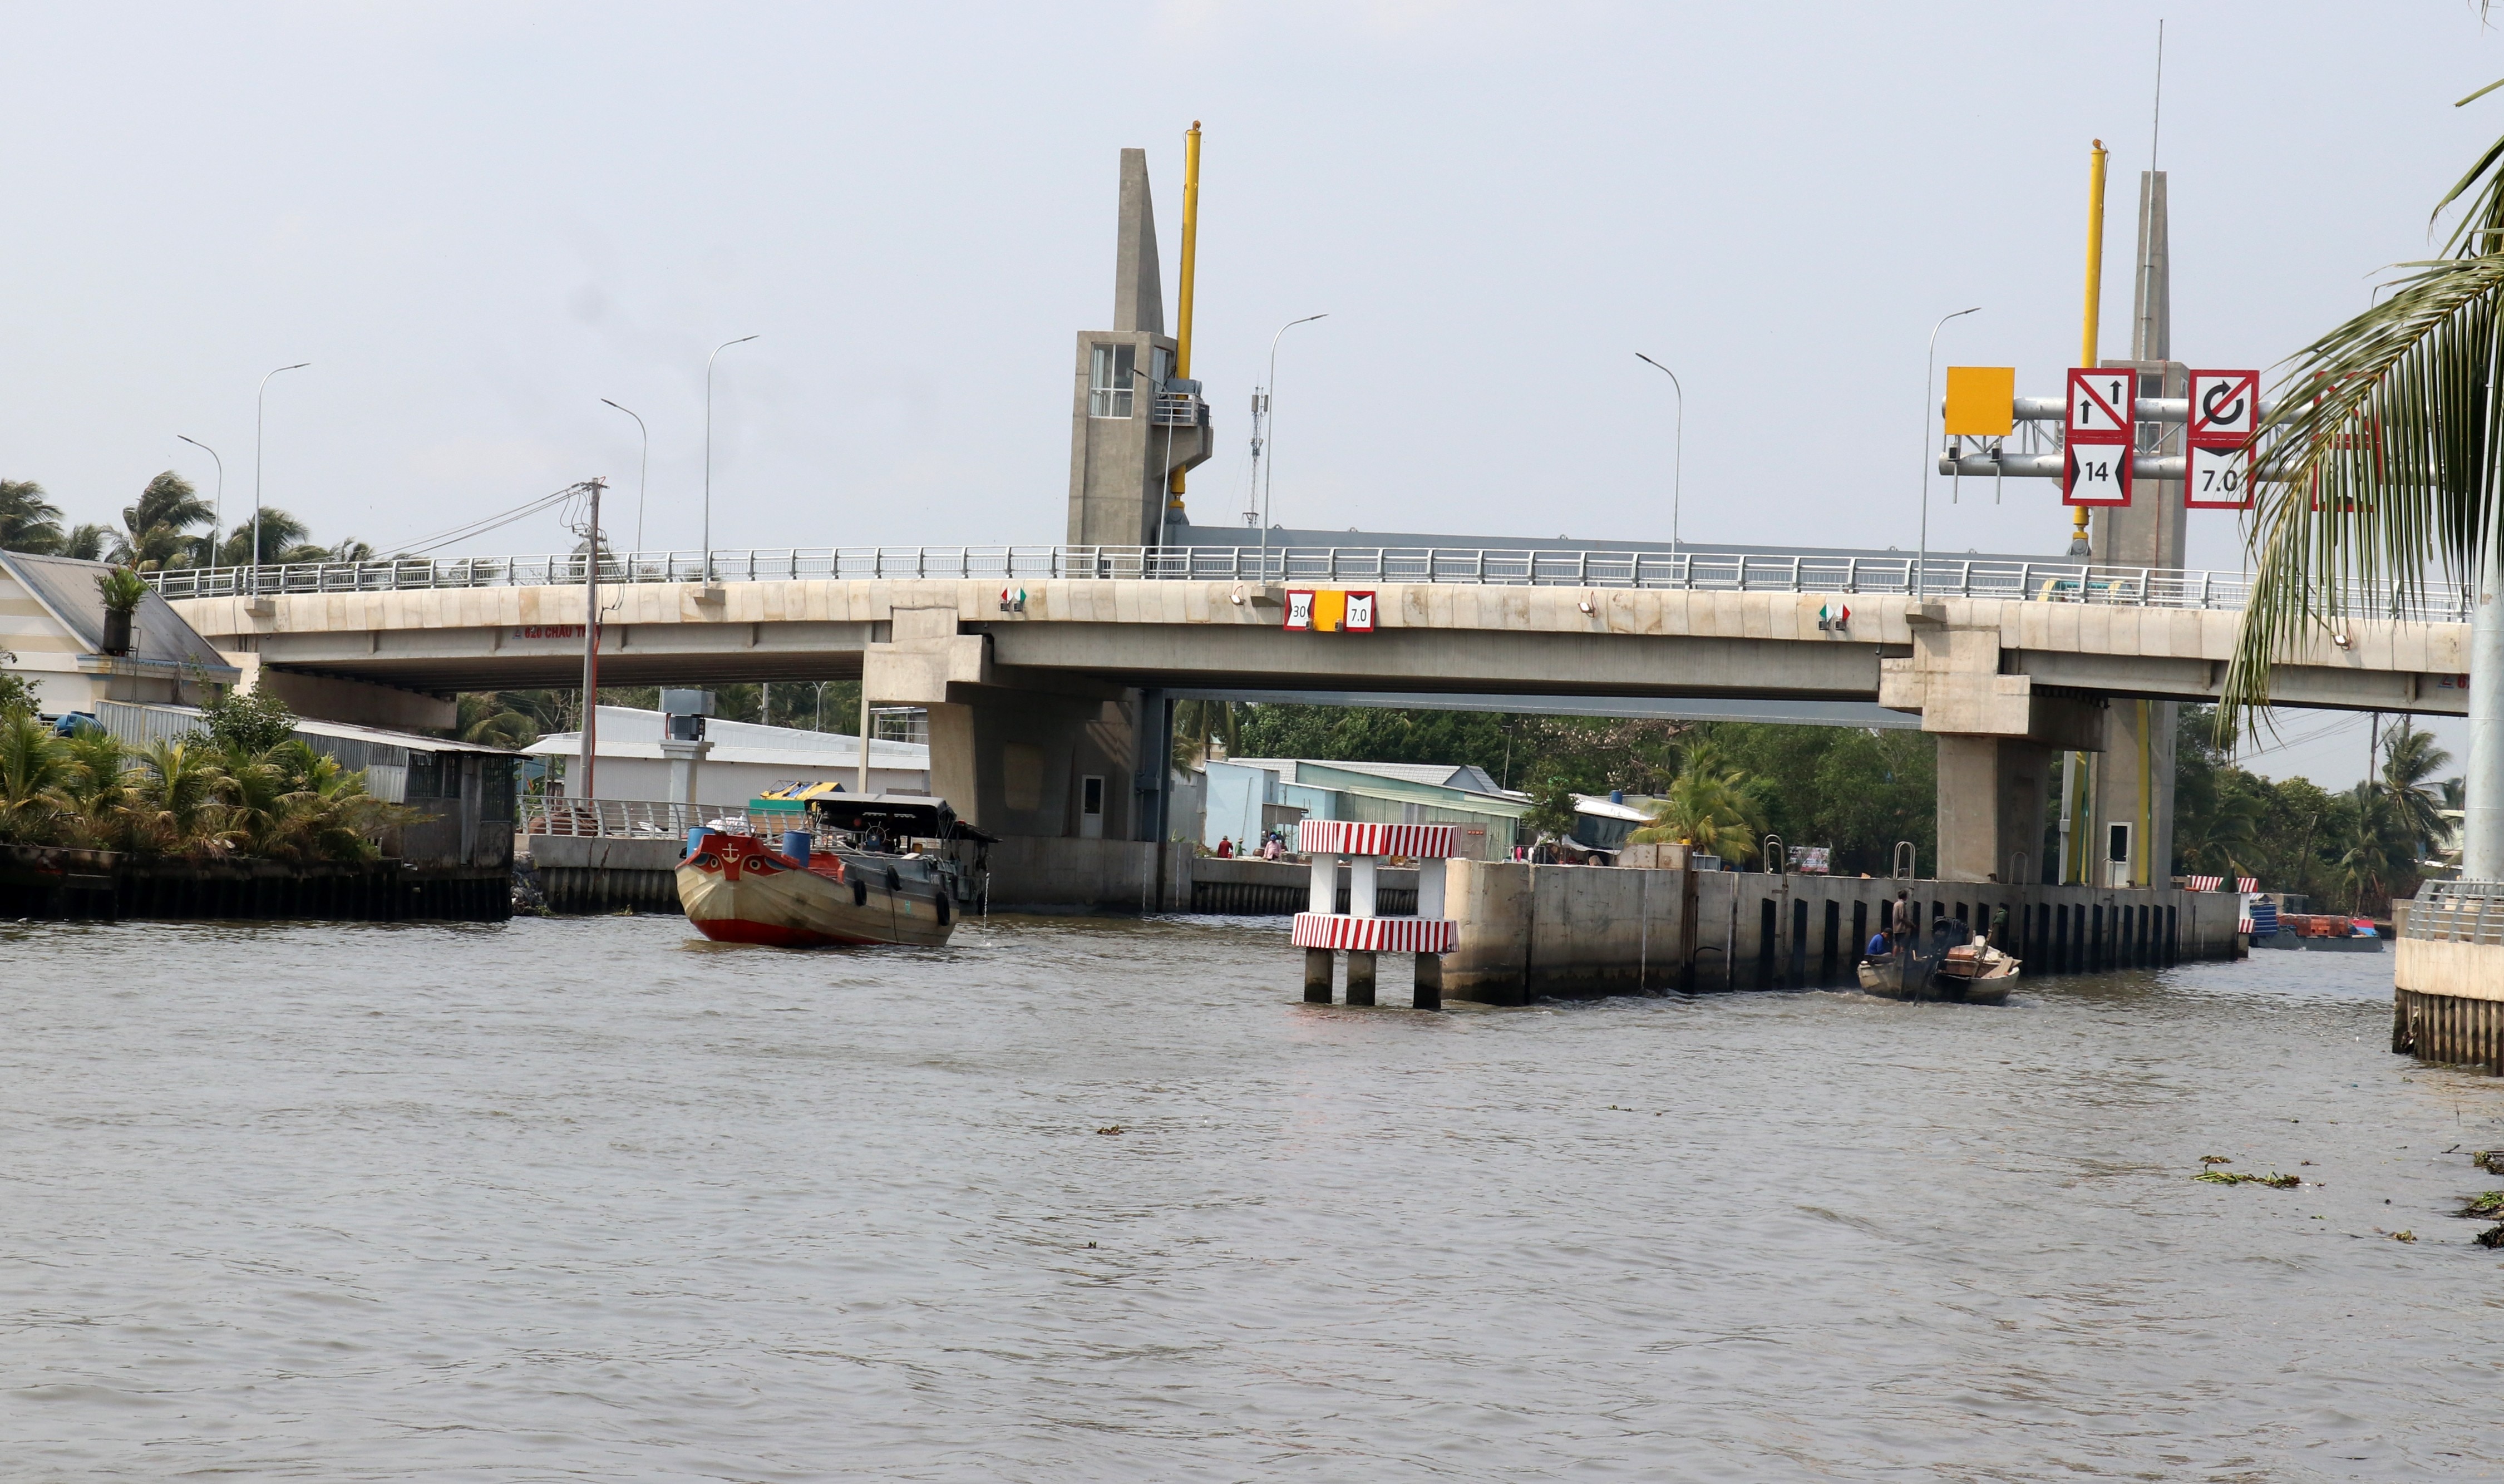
[679, 796, 989, 949]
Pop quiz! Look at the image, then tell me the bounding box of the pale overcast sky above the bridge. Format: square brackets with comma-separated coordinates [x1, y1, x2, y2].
[0, 0, 2504, 783]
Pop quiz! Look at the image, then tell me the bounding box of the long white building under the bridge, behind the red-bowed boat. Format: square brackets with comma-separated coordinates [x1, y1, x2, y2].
[524, 706, 931, 808]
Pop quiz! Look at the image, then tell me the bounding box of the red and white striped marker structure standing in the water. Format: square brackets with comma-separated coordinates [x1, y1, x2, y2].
[1295, 819, 1460, 1011]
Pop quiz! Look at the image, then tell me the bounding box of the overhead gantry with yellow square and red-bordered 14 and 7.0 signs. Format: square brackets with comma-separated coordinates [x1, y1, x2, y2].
[1938, 366, 2269, 510]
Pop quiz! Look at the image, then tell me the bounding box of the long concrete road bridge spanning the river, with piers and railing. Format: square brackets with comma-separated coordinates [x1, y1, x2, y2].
[155, 545, 2469, 881]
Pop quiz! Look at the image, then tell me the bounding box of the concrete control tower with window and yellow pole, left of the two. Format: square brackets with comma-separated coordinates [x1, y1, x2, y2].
[1069, 146, 1215, 545]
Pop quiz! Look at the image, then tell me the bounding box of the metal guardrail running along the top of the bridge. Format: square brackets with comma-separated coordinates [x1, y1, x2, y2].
[148, 545, 2469, 623]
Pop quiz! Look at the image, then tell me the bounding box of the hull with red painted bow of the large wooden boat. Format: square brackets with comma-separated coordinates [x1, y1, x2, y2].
[679, 836, 957, 949]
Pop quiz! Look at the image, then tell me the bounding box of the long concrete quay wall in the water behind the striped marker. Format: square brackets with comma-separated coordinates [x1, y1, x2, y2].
[1442, 861, 2241, 1003]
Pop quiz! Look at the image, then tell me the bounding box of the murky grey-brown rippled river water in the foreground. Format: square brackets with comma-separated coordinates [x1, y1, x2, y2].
[0, 919, 2504, 1482]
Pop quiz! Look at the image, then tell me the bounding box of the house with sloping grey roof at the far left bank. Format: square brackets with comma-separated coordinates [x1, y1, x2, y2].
[0, 550, 243, 716]
